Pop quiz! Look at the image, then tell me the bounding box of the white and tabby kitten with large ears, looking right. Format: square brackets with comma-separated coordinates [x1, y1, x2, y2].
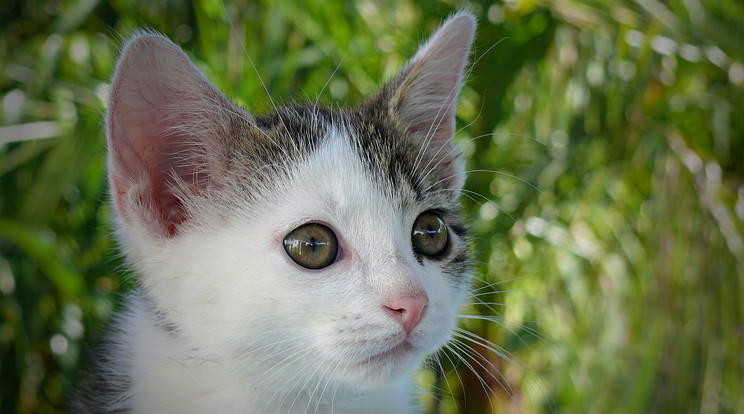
[72, 13, 475, 413]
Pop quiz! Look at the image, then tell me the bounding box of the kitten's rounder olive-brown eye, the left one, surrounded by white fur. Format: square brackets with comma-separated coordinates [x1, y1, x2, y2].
[284, 223, 338, 269]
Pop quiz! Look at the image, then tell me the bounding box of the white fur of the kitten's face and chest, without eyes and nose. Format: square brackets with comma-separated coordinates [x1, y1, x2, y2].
[108, 127, 464, 413]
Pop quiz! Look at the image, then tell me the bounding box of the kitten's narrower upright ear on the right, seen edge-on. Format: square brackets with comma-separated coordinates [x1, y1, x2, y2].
[382, 12, 475, 190]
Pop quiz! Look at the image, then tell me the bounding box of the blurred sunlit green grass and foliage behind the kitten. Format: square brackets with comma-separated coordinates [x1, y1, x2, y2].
[0, 0, 744, 413]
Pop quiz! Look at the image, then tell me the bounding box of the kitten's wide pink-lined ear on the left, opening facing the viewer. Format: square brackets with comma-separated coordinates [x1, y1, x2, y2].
[106, 34, 252, 237]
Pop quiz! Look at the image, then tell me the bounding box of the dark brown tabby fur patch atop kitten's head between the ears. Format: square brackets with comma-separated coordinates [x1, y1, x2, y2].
[254, 106, 455, 208]
